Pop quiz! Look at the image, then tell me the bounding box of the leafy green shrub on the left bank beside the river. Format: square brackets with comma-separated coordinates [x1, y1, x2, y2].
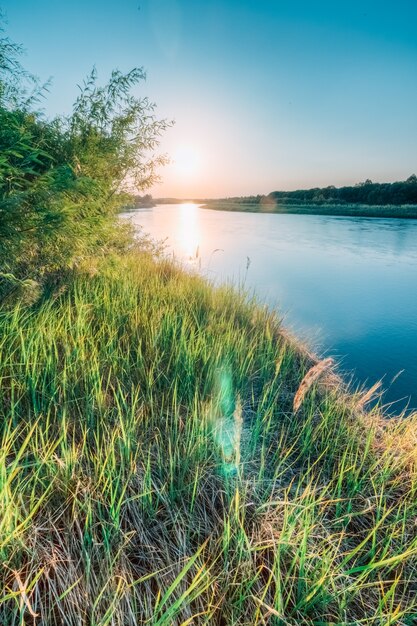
[0, 17, 170, 295]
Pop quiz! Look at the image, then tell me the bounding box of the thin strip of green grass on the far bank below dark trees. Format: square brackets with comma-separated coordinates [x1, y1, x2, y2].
[204, 199, 417, 219]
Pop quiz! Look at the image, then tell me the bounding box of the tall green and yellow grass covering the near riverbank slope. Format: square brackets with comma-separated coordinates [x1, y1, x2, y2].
[0, 254, 417, 626]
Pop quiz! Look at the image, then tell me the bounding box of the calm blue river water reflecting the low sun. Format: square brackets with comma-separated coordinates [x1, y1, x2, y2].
[125, 203, 417, 413]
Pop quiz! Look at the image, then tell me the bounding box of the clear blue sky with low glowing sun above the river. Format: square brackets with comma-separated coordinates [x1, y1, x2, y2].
[0, 0, 417, 197]
